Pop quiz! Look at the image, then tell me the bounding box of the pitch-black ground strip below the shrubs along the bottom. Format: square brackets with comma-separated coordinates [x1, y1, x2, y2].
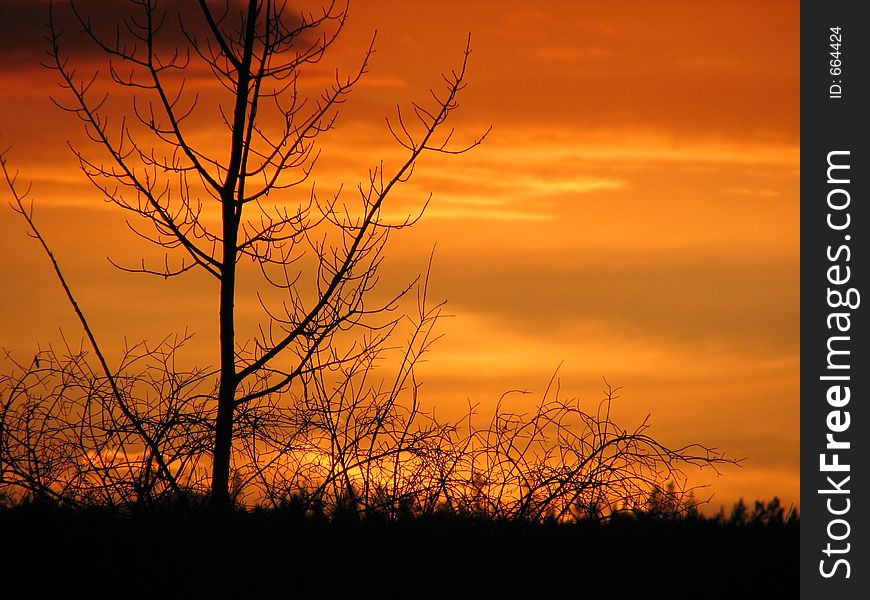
[0, 503, 799, 598]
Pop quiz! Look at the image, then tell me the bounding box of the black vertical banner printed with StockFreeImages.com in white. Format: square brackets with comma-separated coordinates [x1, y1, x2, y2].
[800, 0, 870, 600]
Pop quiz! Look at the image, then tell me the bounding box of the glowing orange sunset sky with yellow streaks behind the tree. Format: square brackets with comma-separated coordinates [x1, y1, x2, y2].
[0, 0, 800, 509]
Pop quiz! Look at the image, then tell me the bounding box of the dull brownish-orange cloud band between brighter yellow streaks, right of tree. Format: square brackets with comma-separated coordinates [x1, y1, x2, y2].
[418, 254, 800, 354]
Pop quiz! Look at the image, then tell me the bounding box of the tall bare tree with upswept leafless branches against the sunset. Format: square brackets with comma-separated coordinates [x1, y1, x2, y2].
[7, 0, 482, 506]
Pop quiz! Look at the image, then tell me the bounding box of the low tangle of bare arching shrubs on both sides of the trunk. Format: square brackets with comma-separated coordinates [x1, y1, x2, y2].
[0, 342, 736, 523]
